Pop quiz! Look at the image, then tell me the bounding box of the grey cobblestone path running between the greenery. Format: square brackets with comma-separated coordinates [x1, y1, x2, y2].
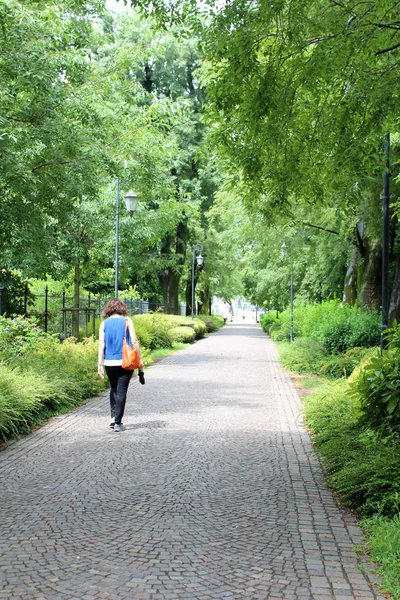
[0, 324, 383, 600]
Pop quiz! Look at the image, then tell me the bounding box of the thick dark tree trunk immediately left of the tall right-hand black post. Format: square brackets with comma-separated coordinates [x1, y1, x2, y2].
[359, 244, 382, 310]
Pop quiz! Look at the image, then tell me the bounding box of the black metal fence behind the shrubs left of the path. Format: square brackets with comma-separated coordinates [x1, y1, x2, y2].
[24, 286, 186, 337]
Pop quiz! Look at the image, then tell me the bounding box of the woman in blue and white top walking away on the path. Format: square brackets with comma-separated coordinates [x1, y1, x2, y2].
[98, 298, 144, 431]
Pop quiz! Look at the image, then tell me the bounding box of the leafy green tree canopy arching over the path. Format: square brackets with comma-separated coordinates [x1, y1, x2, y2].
[0, 0, 400, 316]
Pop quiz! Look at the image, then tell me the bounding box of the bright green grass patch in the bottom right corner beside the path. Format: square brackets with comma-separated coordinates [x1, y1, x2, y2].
[361, 515, 400, 600]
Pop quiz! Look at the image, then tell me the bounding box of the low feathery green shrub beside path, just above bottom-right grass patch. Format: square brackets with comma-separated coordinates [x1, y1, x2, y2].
[305, 381, 400, 516]
